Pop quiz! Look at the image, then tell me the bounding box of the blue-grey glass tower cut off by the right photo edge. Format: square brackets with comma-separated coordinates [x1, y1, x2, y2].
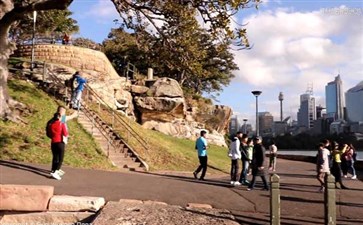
[345, 81, 363, 122]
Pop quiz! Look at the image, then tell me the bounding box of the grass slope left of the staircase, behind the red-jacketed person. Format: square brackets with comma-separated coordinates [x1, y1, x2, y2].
[0, 79, 114, 170]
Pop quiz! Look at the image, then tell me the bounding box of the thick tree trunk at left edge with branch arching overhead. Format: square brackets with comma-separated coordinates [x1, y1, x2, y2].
[0, 0, 72, 120]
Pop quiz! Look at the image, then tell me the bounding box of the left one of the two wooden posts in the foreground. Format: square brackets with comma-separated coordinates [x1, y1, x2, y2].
[270, 174, 280, 225]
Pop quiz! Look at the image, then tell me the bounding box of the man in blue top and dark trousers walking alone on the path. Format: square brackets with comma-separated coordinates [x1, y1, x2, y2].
[193, 130, 208, 180]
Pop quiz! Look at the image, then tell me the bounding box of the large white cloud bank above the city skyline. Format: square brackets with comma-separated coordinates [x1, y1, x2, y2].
[228, 6, 363, 118]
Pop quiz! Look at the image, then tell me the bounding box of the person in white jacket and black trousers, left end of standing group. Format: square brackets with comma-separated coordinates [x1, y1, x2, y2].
[228, 132, 242, 186]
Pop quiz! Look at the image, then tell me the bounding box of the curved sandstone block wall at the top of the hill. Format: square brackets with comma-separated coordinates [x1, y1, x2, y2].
[14, 44, 119, 78]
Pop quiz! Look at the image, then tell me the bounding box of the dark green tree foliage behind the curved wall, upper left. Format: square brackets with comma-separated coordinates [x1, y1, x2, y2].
[10, 9, 79, 41]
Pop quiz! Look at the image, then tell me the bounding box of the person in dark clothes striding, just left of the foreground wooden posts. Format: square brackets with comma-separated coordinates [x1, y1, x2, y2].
[247, 137, 270, 191]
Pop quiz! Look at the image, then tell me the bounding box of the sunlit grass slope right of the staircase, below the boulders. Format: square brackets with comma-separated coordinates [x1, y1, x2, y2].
[91, 104, 230, 173]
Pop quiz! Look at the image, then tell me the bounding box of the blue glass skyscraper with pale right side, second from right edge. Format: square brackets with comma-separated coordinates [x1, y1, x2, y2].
[325, 75, 345, 120]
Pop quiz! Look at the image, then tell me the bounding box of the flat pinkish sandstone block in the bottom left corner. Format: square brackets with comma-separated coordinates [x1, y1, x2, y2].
[0, 184, 54, 211]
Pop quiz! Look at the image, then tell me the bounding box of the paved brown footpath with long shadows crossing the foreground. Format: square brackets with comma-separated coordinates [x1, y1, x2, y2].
[0, 159, 363, 224]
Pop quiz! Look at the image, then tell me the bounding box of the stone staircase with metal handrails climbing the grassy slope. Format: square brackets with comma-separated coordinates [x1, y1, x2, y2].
[11, 59, 149, 171]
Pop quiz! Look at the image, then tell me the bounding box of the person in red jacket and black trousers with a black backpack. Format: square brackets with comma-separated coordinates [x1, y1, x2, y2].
[48, 113, 68, 180]
